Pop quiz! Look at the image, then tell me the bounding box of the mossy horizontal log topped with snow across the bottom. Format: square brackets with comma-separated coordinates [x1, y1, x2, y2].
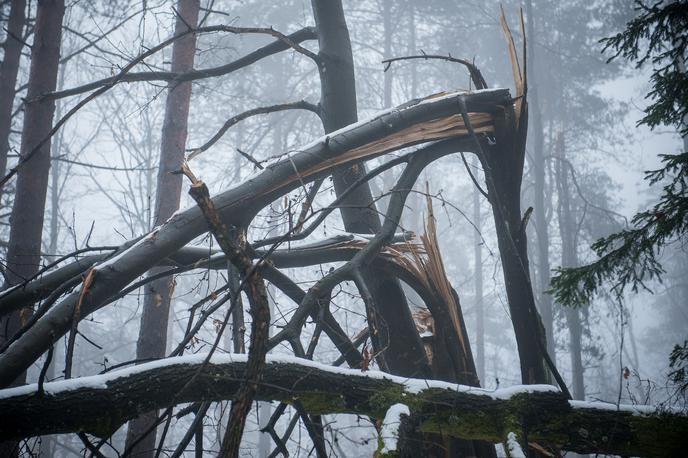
[0, 354, 688, 456]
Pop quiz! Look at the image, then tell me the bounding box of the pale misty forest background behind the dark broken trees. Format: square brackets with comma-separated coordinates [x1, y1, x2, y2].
[0, 0, 688, 456]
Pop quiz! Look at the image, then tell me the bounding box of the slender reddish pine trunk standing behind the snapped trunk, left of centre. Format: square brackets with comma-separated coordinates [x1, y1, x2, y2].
[126, 0, 200, 457]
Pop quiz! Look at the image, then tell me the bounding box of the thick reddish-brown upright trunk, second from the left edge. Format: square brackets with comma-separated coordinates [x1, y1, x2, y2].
[0, 0, 64, 456]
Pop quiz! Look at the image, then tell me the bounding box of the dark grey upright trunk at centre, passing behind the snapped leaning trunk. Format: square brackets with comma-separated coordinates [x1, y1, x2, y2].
[311, 0, 430, 377]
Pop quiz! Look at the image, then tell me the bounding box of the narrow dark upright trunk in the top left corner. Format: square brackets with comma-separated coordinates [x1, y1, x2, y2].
[0, 0, 26, 195]
